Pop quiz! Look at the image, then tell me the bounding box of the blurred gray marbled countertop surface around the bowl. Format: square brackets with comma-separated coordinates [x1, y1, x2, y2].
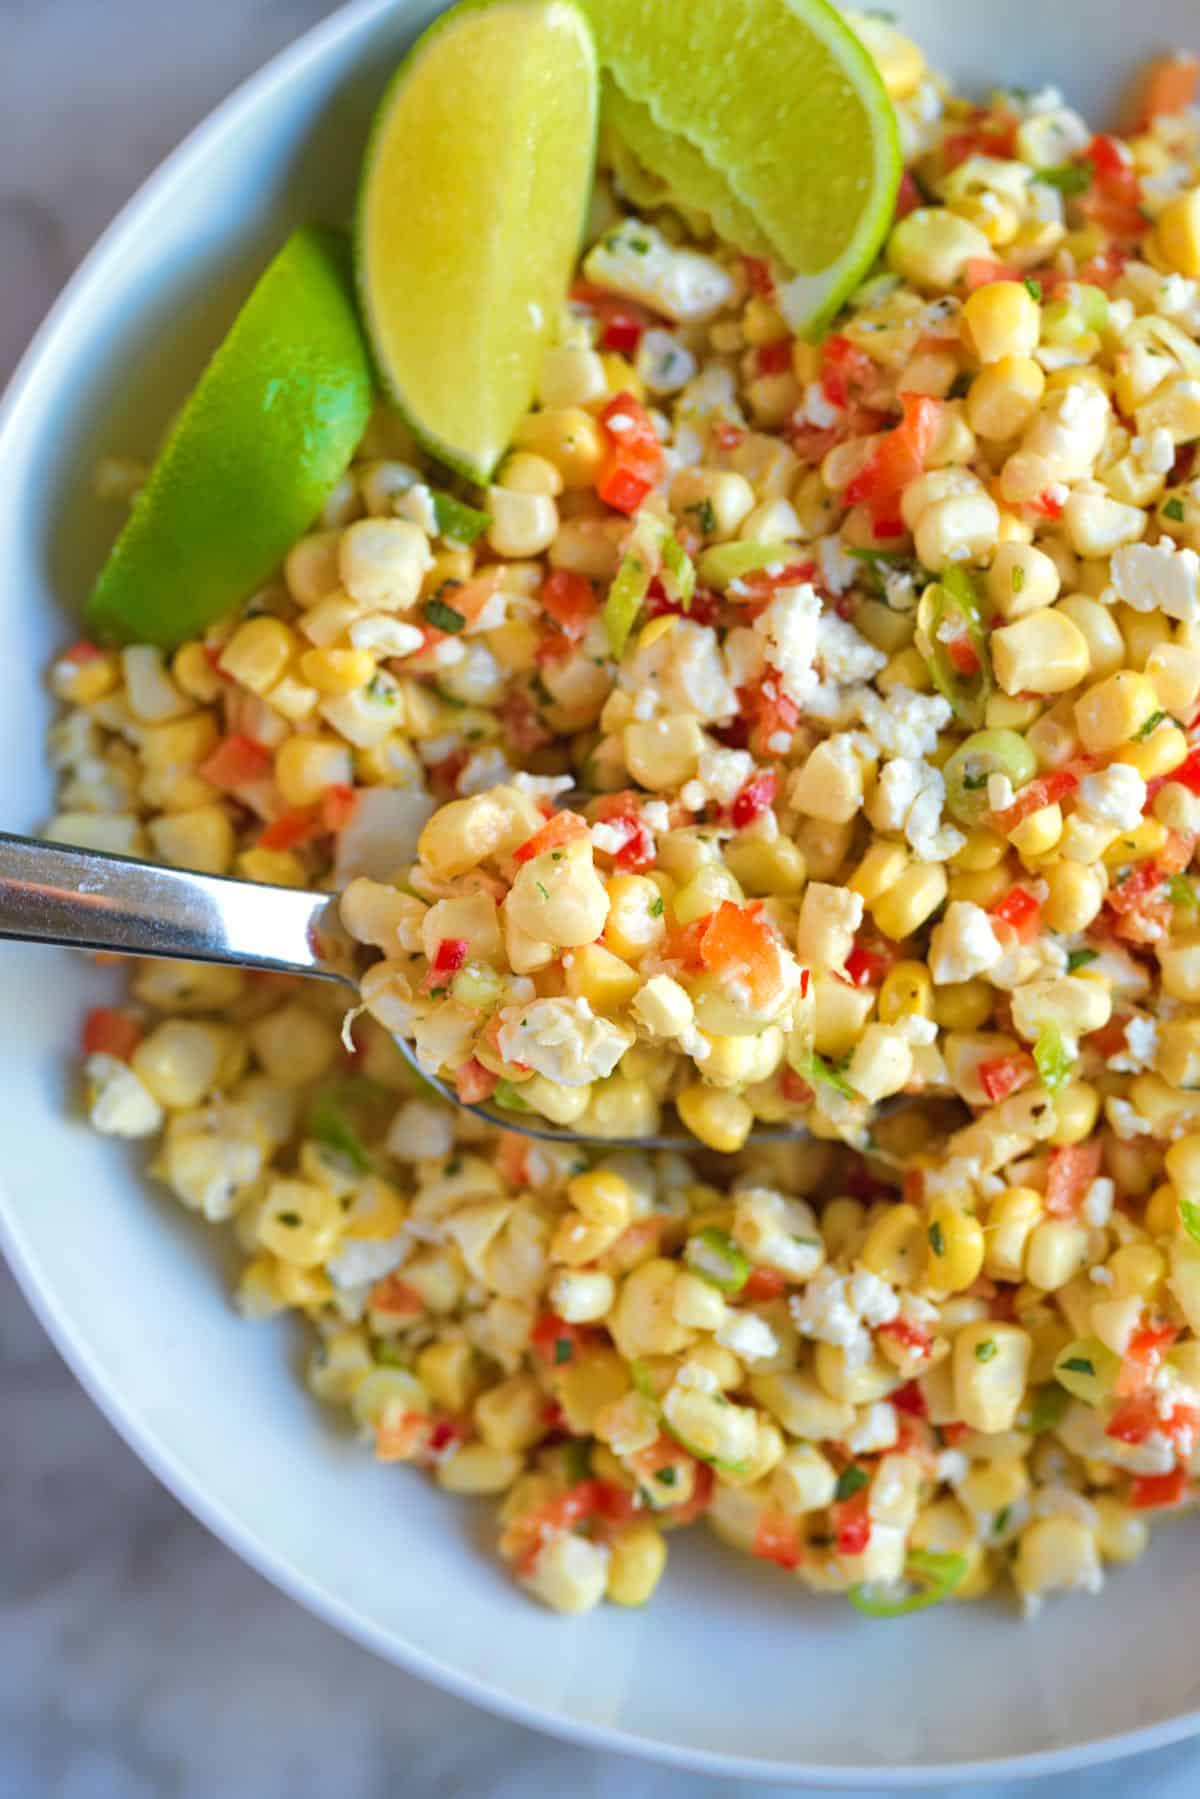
[0, 0, 1200, 1799]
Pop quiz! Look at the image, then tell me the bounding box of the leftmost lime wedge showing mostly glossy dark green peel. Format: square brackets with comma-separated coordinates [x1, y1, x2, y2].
[86, 228, 371, 649]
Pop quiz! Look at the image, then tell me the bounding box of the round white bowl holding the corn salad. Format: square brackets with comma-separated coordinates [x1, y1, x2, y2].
[0, 0, 1200, 1788]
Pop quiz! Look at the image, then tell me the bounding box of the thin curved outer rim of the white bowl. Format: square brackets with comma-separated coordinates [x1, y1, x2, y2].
[0, 0, 1200, 1790]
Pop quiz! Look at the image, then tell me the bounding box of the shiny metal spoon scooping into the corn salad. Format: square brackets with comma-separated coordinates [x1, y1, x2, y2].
[0, 831, 852, 1150]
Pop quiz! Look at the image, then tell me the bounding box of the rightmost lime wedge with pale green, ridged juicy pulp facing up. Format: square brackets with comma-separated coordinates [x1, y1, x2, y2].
[585, 0, 901, 331]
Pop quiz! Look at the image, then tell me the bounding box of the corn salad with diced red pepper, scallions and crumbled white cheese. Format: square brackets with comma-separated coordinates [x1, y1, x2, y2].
[47, 31, 1200, 1616]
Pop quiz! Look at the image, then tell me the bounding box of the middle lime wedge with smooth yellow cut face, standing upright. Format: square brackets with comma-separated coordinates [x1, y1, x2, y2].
[358, 0, 597, 482]
